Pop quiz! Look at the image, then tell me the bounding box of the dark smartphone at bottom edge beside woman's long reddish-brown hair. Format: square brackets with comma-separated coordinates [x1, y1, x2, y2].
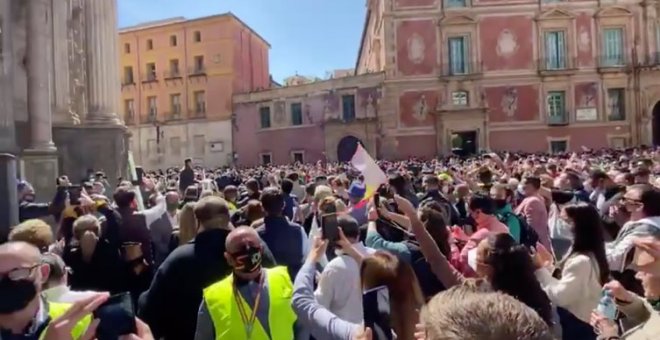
[362, 286, 392, 340]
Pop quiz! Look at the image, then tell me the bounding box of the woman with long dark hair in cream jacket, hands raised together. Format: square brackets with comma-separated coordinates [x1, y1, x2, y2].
[535, 203, 610, 340]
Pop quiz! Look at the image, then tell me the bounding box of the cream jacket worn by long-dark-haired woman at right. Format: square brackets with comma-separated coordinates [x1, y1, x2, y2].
[536, 253, 602, 323]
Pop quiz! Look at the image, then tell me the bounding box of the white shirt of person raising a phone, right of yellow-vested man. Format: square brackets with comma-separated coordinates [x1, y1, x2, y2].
[314, 242, 376, 324]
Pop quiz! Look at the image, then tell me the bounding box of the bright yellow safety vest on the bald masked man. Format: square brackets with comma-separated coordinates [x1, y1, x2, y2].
[204, 267, 296, 340]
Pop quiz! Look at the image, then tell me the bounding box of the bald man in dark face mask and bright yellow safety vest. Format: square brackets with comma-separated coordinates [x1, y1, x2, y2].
[195, 227, 296, 340]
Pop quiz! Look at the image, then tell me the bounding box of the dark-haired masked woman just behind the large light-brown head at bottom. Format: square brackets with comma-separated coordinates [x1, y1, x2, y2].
[476, 233, 555, 328]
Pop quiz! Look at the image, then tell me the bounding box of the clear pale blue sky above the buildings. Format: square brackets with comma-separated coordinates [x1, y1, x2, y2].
[118, 0, 366, 81]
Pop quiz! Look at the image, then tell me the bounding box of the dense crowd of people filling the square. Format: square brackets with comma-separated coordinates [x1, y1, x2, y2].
[0, 148, 660, 340]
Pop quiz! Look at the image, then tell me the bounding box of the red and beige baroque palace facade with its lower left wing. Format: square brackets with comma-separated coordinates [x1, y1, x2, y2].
[233, 0, 660, 165]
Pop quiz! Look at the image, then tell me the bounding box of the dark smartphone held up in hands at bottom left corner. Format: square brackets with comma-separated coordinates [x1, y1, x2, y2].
[94, 293, 136, 340]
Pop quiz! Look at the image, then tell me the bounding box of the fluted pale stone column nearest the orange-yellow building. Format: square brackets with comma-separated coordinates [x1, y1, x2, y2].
[84, 0, 121, 125]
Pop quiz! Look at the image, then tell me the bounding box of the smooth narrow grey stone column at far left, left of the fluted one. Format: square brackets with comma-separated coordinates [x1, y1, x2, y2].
[27, 0, 55, 152]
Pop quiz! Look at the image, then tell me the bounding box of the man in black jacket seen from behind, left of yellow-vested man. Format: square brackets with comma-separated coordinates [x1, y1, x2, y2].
[138, 196, 275, 340]
